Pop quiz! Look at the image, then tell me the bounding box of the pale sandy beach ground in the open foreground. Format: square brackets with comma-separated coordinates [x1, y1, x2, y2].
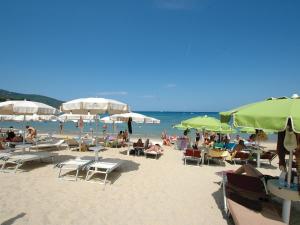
[0, 140, 300, 225]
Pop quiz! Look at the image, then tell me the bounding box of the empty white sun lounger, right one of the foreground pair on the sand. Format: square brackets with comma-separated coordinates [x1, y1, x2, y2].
[85, 159, 123, 185]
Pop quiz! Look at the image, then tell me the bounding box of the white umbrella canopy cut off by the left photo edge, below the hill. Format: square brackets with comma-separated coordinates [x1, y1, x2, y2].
[0, 100, 58, 115]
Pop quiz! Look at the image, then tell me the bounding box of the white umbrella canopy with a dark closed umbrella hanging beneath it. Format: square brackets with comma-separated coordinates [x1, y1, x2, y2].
[110, 112, 160, 124]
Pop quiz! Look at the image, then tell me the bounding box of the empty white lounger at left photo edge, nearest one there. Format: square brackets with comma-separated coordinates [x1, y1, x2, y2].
[1, 152, 57, 172]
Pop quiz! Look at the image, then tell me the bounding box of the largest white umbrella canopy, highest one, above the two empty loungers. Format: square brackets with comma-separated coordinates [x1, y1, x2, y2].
[61, 98, 129, 114]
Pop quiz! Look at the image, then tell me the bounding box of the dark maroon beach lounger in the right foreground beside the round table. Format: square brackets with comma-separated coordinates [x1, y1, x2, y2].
[223, 173, 284, 225]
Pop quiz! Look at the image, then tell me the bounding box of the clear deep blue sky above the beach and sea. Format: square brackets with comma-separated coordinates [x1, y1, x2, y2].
[0, 0, 300, 111]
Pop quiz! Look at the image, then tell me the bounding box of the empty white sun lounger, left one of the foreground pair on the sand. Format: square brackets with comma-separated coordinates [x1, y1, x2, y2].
[56, 158, 93, 181]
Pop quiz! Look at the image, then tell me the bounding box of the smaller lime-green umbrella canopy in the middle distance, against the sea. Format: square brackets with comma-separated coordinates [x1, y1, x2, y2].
[181, 115, 229, 131]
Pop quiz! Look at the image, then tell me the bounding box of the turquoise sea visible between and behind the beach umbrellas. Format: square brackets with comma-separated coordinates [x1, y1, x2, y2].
[0, 111, 276, 140]
